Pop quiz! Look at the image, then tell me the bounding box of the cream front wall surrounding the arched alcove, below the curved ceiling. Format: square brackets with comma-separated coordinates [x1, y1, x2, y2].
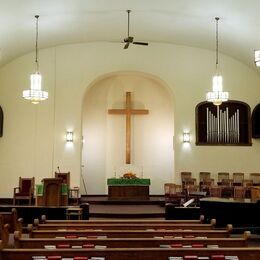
[0, 43, 260, 197]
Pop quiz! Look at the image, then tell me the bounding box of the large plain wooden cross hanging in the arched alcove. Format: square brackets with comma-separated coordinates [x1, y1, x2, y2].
[108, 92, 149, 164]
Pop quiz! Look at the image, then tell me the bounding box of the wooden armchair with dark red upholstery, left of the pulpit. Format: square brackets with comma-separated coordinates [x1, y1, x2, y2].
[13, 177, 35, 205]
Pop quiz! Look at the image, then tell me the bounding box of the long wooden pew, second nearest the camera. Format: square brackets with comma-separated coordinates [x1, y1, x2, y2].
[14, 231, 250, 248]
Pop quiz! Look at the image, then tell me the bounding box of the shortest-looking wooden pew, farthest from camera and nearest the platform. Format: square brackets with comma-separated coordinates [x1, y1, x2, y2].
[41, 215, 204, 224]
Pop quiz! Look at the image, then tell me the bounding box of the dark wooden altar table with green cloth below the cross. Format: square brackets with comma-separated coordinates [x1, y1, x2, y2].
[107, 178, 151, 200]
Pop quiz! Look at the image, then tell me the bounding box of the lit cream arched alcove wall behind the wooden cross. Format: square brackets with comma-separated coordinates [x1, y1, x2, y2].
[82, 72, 174, 194]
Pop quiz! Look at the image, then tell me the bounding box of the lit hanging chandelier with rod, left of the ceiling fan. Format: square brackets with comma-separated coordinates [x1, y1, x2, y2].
[23, 15, 48, 104]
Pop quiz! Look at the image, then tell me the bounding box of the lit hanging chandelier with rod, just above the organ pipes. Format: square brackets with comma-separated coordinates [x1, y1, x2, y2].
[206, 17, 229, 106]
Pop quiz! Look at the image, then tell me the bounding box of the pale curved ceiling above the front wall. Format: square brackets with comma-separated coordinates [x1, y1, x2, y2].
[0, 0, 260, 67]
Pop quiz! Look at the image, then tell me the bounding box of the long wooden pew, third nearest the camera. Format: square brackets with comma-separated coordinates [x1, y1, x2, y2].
[28, 225, 232, 238]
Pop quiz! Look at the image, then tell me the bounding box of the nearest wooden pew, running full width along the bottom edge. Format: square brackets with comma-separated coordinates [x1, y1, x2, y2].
[0, 244, 260, 260]
